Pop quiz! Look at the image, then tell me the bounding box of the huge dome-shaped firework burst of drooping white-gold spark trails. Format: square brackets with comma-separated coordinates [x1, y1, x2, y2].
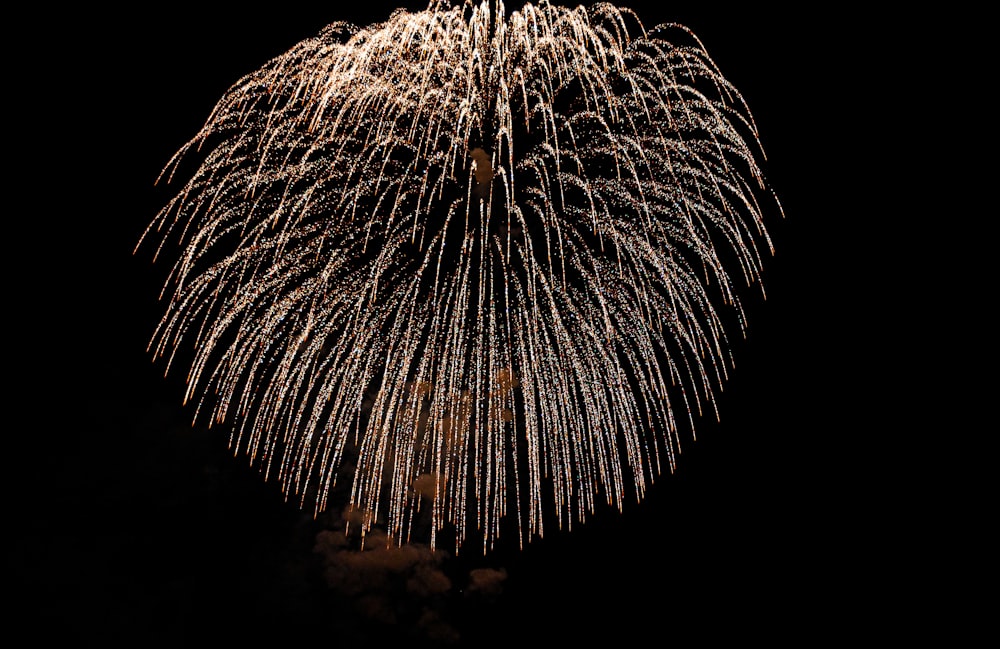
[140, 0, 780, 551]
